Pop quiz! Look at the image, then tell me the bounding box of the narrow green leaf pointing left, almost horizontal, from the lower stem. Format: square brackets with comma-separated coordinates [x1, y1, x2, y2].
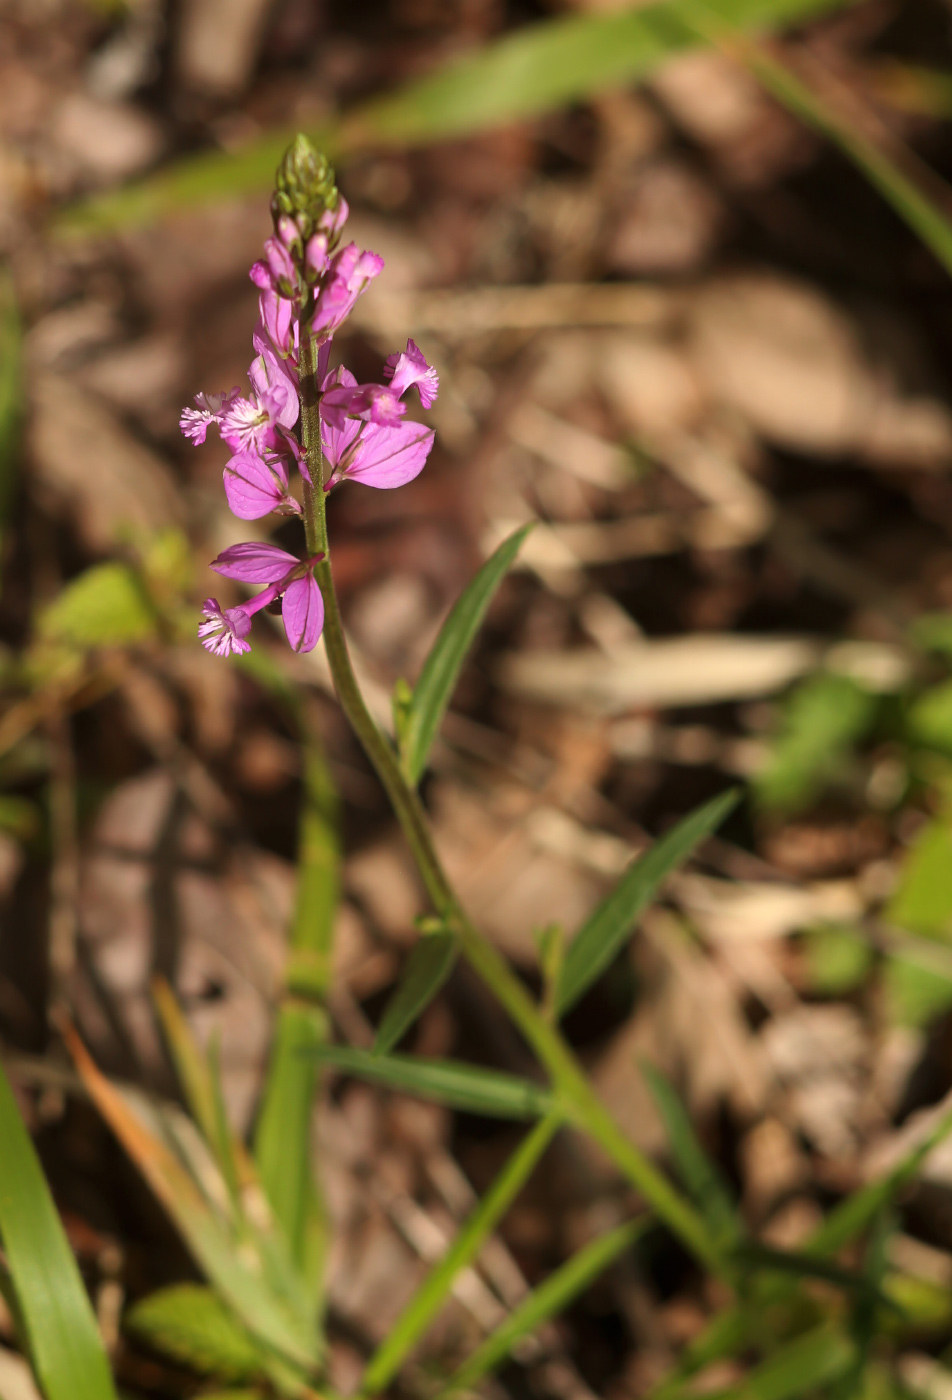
[318, 1046, 553, 1119]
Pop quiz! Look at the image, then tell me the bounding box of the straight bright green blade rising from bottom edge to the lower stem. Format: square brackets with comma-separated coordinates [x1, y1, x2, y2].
[360, 1114, 561, 1394]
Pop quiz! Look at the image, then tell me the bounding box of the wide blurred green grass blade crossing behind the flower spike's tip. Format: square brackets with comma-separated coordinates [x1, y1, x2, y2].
[59, 0, 848, 232]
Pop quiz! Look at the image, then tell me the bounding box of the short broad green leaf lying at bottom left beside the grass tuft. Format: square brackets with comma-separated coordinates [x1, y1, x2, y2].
[125, 1284, 263, 1380]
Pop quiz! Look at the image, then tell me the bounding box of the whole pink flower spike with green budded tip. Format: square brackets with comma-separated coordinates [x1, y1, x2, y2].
[181, 137, 440, 657]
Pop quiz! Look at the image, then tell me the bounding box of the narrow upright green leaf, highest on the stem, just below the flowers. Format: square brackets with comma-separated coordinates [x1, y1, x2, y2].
[399, 524, 532, 783]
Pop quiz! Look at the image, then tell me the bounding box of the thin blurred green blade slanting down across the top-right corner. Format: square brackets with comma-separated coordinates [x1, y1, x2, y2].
[685, 0, 952, 273]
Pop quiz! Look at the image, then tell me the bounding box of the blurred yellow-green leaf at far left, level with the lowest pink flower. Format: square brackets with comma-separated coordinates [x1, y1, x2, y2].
[39, 561, 155, 647]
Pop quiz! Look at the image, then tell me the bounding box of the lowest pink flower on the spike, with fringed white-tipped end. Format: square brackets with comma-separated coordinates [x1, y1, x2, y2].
[199, 540, 323, 657]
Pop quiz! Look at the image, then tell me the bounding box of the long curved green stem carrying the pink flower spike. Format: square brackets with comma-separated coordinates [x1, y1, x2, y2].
[301, 333, 728, 1275]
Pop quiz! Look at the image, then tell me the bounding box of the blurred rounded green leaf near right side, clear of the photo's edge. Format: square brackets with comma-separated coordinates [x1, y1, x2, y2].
[755, 673, 876, 812]
